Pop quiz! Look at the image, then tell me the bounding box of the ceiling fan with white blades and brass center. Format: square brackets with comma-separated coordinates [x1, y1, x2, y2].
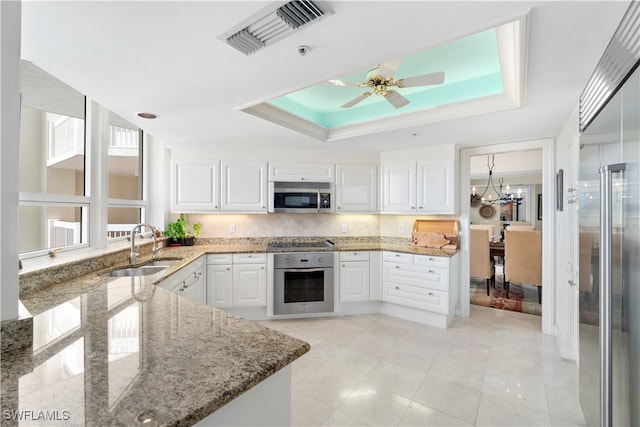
[329, 59, 444, 108]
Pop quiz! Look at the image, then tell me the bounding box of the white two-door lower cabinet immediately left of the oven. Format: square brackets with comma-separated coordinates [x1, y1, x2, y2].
[207, 253, 267, 308]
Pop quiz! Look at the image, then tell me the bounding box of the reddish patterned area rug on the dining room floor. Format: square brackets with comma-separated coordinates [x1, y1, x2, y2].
[469, 275, 544, 316]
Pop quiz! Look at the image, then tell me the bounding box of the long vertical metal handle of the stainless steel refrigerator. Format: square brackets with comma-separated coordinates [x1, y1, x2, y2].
[599, 163, 626, 427]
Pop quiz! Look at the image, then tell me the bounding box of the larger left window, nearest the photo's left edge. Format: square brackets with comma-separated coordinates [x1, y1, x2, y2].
[18, 61, 90, 255]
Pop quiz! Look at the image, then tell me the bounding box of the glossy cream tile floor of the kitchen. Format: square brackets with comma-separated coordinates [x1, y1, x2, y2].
[262, 306, 584, 426]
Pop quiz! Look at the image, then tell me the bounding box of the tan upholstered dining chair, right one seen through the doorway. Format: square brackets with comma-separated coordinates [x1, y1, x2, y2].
[504, 228, 542, 304]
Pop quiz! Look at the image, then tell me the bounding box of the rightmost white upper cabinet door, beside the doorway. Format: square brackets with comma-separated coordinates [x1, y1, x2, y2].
[417, 160, 455, 214]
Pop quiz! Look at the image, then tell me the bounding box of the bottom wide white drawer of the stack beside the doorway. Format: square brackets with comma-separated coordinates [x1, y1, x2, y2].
[382, 284, 449, 314]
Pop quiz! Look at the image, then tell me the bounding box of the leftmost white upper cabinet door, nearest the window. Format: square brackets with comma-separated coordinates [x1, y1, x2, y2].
[171, 160, 220, 212]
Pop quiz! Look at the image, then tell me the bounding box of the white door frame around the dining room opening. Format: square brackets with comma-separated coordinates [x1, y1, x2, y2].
[458, 138, 555, 335]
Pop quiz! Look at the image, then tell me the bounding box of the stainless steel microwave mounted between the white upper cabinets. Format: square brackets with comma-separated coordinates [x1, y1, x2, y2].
[269, 182, 333, 213]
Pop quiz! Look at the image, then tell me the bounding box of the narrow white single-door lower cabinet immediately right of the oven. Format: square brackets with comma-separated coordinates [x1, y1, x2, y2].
[340, 251, 370, 302]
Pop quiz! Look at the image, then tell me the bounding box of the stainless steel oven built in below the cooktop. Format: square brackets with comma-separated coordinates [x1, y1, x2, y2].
[273, 252, 334, 315]
